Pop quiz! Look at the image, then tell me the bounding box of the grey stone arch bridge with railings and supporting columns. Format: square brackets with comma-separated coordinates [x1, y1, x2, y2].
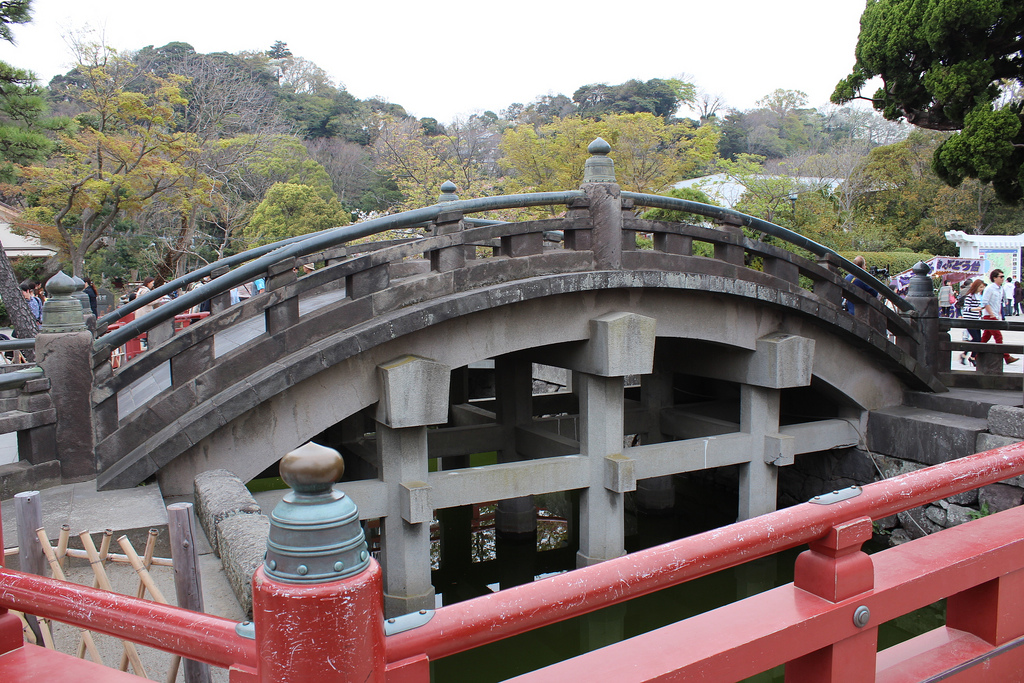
[4, 147, 944, 613]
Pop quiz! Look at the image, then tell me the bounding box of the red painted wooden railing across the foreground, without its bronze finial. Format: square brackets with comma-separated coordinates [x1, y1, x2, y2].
[0, 444, 1024, 683]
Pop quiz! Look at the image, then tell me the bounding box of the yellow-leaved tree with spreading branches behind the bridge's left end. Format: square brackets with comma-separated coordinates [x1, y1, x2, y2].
[24, 44, 206, 276]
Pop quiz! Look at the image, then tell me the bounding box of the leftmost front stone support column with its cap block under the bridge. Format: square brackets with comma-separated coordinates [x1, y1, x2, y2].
[376, 356, 450, 617]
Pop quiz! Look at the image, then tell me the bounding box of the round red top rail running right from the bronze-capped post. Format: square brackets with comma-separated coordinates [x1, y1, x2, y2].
[387, 444, 1024, 663]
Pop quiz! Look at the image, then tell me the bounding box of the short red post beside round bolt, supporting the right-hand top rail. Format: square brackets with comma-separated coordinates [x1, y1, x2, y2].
[785, 517, 879, 683]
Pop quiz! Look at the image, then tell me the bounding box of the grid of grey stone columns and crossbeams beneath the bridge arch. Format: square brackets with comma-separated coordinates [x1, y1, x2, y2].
[364, 311, 814, 615]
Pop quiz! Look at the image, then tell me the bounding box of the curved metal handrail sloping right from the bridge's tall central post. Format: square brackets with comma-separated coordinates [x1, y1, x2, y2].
[623, 191, 914, 311]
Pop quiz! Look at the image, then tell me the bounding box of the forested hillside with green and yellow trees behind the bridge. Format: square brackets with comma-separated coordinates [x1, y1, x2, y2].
[0, 30, 1024, 279]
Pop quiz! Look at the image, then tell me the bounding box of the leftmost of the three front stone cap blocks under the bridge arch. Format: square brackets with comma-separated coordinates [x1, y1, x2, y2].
[376, 355, 451, 429]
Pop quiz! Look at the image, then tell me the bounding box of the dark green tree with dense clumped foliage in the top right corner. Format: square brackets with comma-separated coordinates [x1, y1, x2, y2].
[831, 0, 1024, 202]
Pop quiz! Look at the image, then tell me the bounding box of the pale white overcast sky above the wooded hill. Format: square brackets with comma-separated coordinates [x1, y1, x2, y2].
[0, 0, 865, 122]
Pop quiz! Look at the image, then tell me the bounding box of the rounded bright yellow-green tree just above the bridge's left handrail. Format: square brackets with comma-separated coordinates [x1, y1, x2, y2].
[244, 182, 350, 247]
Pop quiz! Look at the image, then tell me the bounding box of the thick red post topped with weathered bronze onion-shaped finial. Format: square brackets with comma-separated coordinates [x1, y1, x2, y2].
[253, 443, 385, 683]
